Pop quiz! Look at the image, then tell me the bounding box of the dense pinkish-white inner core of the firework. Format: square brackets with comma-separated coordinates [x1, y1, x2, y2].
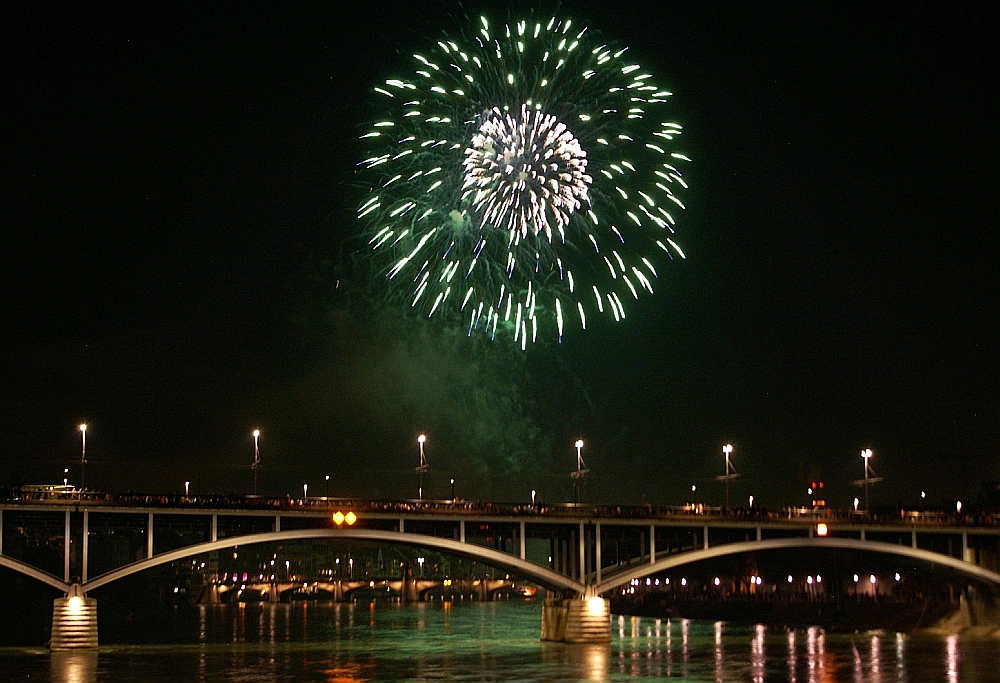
[462, 105, 593, 243]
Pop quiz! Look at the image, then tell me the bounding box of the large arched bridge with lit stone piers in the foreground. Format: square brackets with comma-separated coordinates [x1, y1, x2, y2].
[0, 493, 1000, 649]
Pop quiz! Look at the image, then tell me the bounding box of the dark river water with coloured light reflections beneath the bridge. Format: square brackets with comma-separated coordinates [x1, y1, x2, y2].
[0, 602, 1000, 683]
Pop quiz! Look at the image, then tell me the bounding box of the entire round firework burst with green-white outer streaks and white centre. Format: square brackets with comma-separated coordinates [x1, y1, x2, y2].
[358, 18, 690, 349]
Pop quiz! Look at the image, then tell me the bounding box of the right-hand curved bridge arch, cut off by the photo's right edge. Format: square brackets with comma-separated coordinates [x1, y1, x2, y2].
[595, 538, 1000, 595]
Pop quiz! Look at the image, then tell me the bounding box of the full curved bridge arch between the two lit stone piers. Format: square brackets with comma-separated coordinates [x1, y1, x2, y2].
[80, 529, 584, 595]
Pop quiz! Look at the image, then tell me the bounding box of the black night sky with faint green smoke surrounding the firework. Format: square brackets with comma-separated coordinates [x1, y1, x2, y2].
[0, 0, 1000, 506]
